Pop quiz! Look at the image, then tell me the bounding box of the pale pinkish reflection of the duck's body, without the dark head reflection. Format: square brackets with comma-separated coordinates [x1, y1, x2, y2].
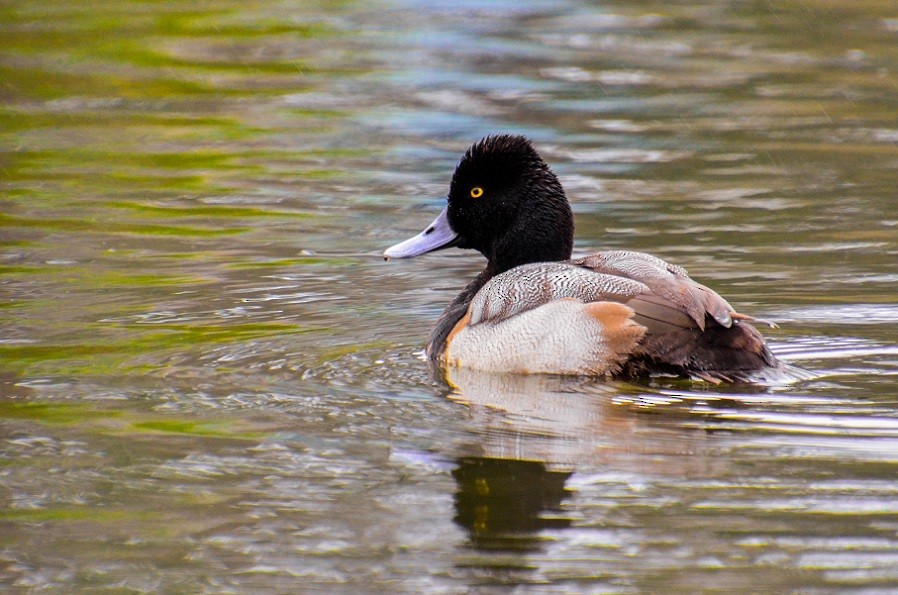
[446, 368, 721, 477]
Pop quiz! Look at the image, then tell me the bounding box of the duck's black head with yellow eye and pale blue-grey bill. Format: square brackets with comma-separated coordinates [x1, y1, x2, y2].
[384, 135, 574, 274]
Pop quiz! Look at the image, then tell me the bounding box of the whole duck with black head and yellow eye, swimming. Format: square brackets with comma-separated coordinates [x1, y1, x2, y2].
[383, 134, 778, 383]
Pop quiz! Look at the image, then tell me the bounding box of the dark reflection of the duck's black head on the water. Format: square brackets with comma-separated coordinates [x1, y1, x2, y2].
[452, 457, 571, 551]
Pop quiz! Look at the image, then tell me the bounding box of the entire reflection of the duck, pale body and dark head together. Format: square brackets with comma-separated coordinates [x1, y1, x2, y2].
[446, 368, 727, 565]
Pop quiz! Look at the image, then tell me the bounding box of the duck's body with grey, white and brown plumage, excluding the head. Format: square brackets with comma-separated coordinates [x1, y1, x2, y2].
[428, 251, 776, 379]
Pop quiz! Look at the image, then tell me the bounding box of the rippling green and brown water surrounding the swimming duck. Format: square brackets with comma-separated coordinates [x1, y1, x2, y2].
[0, 0, 898, 593]
